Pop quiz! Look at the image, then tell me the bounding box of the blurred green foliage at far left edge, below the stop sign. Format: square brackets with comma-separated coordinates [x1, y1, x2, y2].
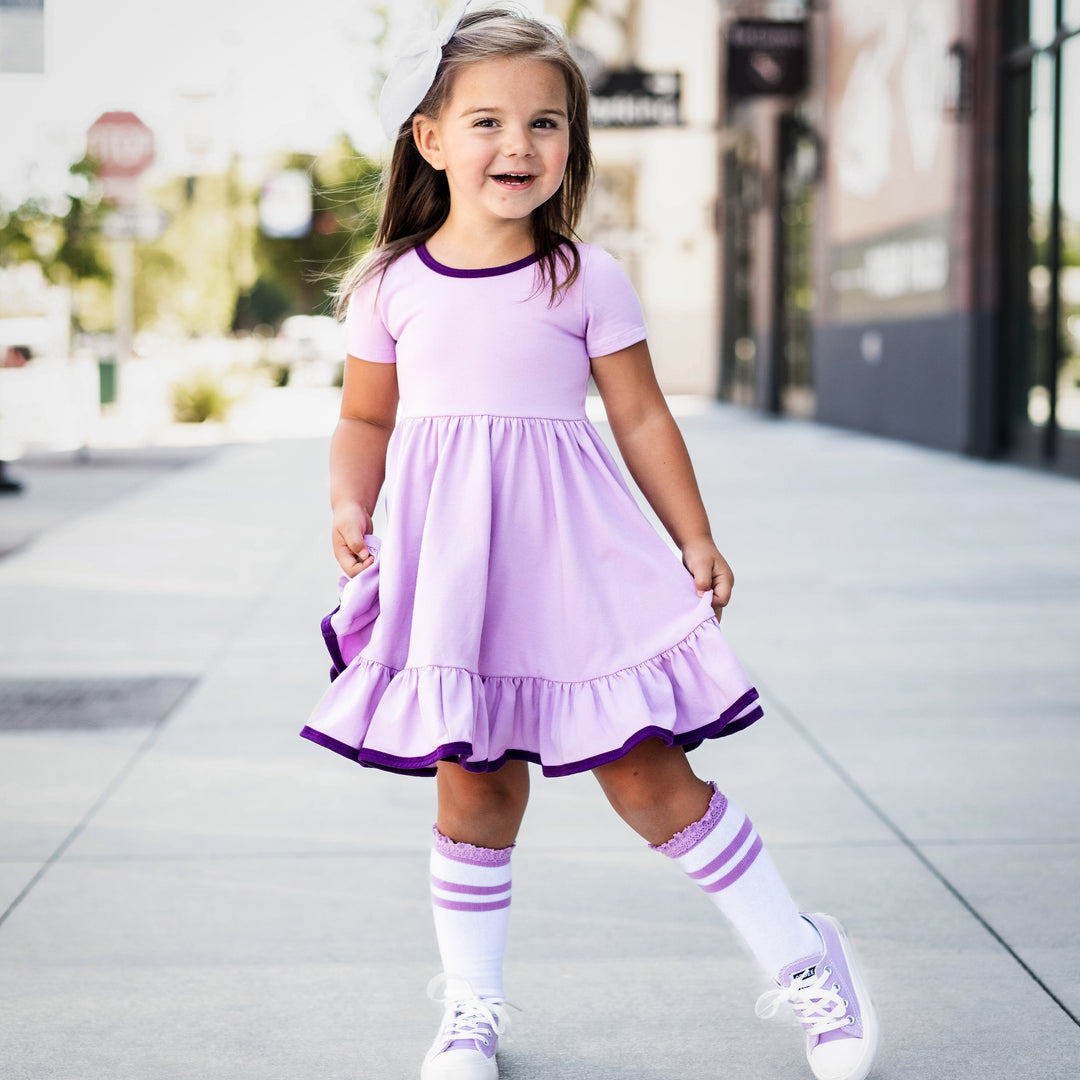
[0, 158, 111, 285]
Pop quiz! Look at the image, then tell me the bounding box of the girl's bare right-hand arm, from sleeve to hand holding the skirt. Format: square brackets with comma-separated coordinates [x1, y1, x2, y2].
[592, 341, 734, 619]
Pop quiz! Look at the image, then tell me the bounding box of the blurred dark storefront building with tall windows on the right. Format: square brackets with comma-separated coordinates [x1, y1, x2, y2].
[718, 0, 1080, 474]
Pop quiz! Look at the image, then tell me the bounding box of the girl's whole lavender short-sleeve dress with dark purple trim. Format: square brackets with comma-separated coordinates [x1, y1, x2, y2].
[301, 244, 761, 777]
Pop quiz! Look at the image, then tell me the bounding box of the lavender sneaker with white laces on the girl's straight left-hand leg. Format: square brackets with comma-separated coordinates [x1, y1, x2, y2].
[420, 975, 510, 1080]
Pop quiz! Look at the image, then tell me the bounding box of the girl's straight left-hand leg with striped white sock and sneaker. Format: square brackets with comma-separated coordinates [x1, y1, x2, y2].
[421, 761, 529, 1080]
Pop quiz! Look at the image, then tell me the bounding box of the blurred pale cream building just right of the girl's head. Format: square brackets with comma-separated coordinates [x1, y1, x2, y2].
[570, 0, 723, 396]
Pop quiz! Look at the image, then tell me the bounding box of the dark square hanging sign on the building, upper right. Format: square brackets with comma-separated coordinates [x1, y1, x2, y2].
[728, 18, 809, 97]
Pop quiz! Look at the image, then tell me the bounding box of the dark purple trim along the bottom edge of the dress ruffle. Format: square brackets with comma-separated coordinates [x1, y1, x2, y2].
[300, 687, 765, 777]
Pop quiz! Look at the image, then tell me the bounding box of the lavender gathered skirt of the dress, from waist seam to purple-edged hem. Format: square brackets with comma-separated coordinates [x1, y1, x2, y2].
[301, 415, 761, 777]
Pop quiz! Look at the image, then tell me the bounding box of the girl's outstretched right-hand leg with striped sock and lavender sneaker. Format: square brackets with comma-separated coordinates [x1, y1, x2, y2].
[595, 739, 878, 1080]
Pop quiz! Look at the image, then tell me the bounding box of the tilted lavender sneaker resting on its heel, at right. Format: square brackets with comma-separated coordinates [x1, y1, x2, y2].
[757, 915, 878, 1080]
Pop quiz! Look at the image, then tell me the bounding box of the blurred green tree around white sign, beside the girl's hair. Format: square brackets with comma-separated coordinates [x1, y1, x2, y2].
[249, 135, 382, 328]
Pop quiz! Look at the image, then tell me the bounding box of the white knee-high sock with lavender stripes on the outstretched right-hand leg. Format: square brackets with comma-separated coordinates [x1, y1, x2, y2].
[653, 784, 822, 980]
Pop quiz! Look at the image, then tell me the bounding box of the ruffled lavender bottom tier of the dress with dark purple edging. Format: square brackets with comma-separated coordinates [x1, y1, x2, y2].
[300, 617, 762, 777]
